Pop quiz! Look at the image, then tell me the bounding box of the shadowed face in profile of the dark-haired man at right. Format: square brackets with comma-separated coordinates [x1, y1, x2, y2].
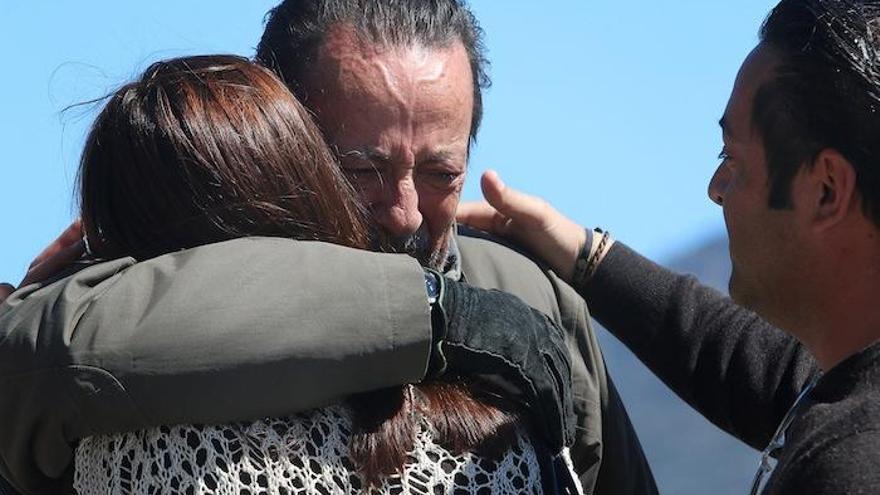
[709, 45, 803, 318]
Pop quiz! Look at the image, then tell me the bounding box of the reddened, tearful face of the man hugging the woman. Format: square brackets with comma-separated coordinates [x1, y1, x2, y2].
[307, 25, 473, 268]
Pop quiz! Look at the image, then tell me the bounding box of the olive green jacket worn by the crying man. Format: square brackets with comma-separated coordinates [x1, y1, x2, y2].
[0, 233, 653, 493]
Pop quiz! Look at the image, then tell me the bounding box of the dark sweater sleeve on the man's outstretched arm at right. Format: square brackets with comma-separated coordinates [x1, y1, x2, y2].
[578, 242, 818, 450]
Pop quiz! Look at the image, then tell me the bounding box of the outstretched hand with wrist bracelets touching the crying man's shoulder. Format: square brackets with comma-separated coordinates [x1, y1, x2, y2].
[456, 170, 587, 280]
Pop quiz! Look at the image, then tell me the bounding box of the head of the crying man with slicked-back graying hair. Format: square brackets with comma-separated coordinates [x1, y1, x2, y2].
[257, 0, 489, 269]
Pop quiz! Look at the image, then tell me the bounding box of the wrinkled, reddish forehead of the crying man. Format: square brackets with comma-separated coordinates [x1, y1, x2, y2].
[305, 25, 473, 143]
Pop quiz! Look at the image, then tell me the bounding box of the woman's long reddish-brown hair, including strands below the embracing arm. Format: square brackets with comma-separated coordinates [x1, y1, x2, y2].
[80, 55, 517, 484]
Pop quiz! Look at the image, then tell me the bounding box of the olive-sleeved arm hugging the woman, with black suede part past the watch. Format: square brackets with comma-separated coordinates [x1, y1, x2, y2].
[0, 234, 574, 493]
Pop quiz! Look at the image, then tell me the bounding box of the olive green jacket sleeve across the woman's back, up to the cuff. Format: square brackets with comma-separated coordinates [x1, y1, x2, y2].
[0, 238, 431, 492]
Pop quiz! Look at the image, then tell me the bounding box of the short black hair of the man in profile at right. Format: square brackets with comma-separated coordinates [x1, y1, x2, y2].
[752, 0, 880, 227]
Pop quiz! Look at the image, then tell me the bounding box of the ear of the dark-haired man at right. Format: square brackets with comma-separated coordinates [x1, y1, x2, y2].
[803, 148, 859, 231]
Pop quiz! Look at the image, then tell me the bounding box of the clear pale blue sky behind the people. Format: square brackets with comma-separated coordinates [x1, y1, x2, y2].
[0, 0, 774, 283]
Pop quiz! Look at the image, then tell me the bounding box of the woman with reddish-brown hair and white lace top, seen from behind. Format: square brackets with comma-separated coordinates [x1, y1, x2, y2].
[74, 56, 580, 494]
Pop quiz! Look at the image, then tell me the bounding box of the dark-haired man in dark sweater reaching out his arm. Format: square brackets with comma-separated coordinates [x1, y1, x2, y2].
[462, 0, 880, 494]
